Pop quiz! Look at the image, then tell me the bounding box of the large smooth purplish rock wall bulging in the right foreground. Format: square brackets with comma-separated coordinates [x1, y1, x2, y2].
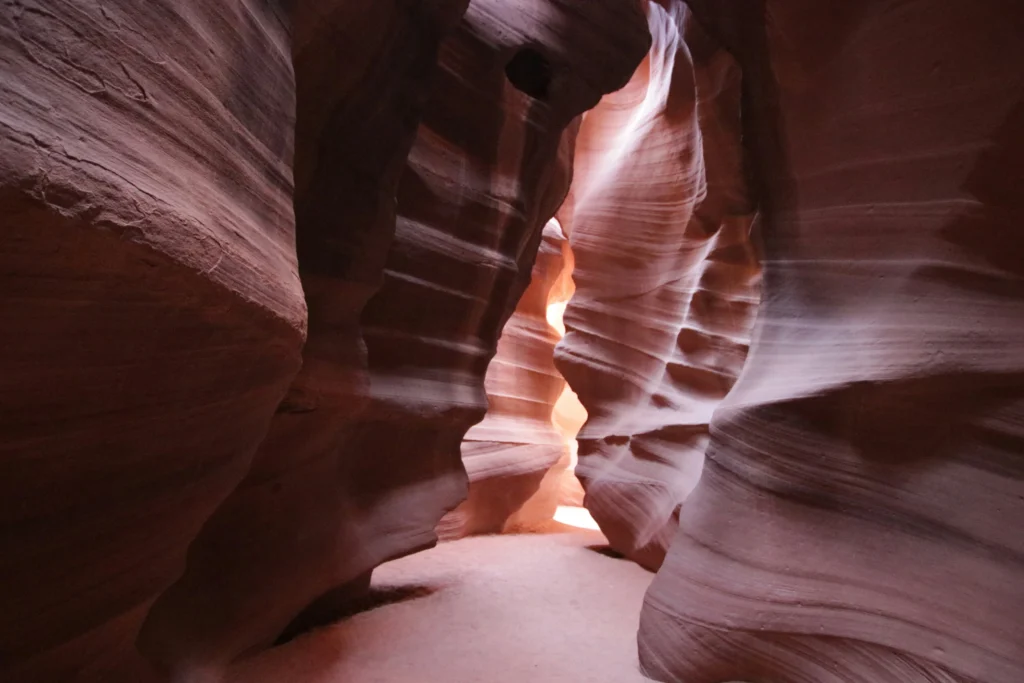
[640, 0, 1024, 683]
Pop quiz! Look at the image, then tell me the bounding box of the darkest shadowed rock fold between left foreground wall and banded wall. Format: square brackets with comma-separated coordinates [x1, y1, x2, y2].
[140, 0, 467, 676]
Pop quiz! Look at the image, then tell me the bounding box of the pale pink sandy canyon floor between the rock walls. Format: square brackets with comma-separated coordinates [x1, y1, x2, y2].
[225, 527, 653, 683]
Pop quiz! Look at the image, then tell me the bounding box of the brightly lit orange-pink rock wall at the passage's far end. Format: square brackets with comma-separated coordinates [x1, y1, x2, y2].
[437, 219, 570, 539]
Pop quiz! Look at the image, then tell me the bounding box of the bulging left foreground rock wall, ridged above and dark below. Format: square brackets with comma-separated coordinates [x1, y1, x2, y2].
[0, 0, 305, 682]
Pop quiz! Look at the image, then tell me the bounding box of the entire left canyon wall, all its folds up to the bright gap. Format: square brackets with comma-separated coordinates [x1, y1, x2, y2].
[0, 0, 648, 682]
